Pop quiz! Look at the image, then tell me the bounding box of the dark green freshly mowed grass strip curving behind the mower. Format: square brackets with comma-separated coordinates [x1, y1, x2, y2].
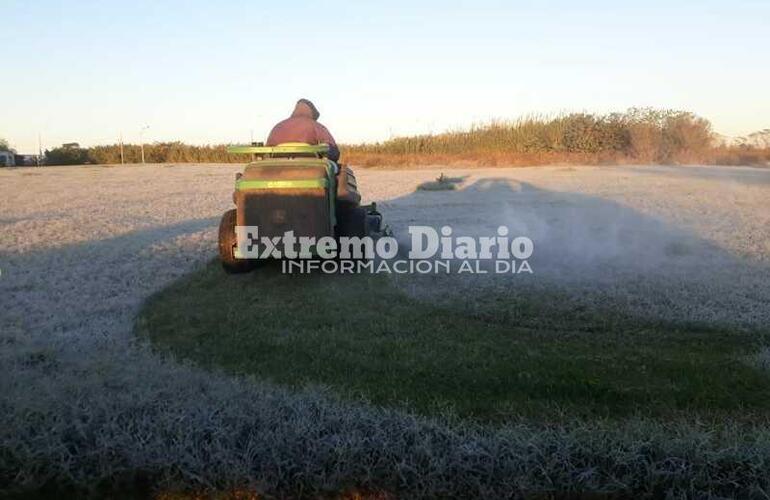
[137, 262, 770, 422]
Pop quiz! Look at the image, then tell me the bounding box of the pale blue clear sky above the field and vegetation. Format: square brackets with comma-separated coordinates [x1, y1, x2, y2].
[0, 0, 770, 153]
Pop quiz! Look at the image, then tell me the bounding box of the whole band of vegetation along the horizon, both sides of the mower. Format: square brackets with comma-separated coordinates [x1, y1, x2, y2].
[46, 109, 770, 166]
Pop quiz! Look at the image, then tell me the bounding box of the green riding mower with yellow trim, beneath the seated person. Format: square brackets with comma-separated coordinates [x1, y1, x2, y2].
[219, 143, 382, 272]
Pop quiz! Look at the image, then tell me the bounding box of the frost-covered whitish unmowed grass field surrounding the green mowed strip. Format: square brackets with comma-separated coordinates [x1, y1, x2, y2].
[0, 165, 770, 496]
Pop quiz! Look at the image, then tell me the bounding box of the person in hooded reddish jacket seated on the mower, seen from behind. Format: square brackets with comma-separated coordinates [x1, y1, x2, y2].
[266, 99, 340, 161]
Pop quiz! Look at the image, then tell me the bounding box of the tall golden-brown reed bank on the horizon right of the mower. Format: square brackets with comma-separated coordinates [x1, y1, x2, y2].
[346, 108, 713, 164]
